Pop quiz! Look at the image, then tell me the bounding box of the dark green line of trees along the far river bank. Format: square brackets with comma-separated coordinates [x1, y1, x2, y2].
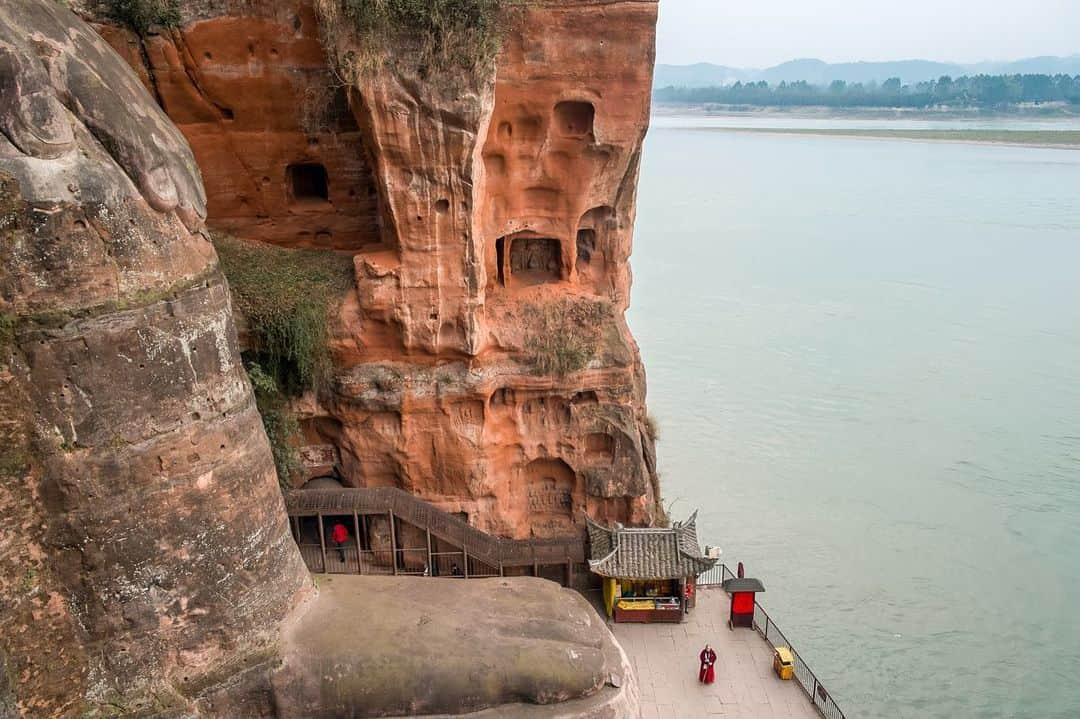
[654, 74, 1080, 108]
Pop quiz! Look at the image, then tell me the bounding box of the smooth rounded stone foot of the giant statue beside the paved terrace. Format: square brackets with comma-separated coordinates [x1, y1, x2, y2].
[273, 575, 638, 719]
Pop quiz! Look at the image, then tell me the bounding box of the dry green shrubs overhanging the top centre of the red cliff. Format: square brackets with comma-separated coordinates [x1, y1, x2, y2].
[316, 0, 522, 79]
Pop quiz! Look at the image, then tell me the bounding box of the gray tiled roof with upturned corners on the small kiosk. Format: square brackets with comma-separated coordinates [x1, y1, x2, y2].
[585, 512, 716, 580]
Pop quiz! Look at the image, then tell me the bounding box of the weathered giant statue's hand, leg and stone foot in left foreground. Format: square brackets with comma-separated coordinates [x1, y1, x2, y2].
[0, 0, 638, 719]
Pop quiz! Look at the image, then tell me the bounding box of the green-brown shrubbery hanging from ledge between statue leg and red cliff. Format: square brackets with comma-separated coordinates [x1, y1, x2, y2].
[214, 235, 353, 395]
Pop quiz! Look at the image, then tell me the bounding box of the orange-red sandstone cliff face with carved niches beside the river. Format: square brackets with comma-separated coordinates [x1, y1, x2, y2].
[92, 0, 658, 537]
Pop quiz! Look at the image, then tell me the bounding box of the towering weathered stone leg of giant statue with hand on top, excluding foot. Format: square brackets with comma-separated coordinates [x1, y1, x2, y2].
[0, 0, 308, 717]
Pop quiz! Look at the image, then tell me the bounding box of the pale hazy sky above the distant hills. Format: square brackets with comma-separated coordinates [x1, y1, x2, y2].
[657, 0, 1080, 67]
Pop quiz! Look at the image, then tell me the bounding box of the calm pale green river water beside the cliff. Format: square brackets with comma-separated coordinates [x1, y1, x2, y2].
[630, 117, 1080, 719]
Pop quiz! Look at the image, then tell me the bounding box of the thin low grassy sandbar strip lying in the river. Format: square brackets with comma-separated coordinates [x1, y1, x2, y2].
[696, 127, 1080, 150]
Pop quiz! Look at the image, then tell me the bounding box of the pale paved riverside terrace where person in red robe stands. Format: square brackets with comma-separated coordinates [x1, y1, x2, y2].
[608, 588, 821, 719]
